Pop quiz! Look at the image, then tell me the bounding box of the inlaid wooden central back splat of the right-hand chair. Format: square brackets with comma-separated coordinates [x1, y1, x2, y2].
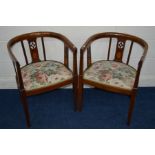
[114, 38, 126, 62]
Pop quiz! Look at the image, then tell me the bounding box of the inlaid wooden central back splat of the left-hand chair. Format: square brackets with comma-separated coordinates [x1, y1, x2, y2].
[28, 38, 40, 62]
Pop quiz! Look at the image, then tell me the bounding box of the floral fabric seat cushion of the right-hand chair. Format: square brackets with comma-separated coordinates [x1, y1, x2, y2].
[84, 60, 136, 90]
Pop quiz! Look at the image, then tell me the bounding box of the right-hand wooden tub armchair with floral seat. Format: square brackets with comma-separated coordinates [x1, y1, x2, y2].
[77, 32, 148, 125]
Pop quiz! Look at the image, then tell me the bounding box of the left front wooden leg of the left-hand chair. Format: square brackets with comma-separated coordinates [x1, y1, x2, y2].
[21, 92, 31, 128]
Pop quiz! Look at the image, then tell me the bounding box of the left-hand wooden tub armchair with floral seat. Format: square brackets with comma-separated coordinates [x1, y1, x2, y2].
[7, 32, 77, 128]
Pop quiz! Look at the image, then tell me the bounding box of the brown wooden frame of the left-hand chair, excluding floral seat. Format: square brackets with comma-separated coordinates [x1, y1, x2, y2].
[7, 32, 78, 127]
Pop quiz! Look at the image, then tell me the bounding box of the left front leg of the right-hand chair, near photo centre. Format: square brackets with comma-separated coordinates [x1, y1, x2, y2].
[76, 76, 83, 112]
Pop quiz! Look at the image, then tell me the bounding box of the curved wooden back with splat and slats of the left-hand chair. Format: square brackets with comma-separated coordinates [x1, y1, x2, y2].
[8, 32, 77, 67]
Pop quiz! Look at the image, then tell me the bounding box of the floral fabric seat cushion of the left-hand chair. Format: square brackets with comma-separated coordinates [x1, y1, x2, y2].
[21, 61, 72, 91]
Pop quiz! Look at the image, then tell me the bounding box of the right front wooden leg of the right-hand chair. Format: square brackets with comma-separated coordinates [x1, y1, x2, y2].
[127, 93, 136, 126]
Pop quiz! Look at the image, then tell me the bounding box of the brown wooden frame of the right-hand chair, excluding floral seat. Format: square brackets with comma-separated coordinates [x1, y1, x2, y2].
[77, 32, 148, 125]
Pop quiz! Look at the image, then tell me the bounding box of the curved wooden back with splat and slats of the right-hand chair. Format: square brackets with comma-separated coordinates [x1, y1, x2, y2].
[81, 32, 148, 71]
